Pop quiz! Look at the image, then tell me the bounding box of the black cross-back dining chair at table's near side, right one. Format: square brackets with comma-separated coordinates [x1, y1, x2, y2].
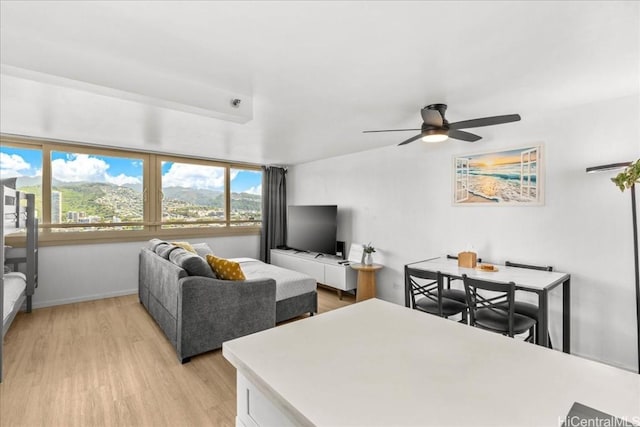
[462, 274, 536, 337]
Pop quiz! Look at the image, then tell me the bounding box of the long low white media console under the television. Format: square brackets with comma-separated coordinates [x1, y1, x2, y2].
[271, 249, 358, 297]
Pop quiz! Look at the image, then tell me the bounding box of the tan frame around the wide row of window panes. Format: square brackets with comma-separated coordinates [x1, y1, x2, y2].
[0, 134, 262, 246]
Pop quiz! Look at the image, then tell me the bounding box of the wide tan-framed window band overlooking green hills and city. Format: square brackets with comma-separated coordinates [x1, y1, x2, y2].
[0, 135, 262, 244]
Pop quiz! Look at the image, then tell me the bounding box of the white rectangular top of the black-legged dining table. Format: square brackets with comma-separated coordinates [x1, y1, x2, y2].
[409, 257, 569, 290]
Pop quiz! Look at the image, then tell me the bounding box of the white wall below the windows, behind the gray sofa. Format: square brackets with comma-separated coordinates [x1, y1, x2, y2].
[33, 235, 260, 308]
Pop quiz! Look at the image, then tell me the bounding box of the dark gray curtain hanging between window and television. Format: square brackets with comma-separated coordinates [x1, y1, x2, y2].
[260, 166, 287, 262]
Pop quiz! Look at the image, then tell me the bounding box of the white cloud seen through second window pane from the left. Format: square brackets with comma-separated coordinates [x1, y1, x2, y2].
[51, 154, 141, 185]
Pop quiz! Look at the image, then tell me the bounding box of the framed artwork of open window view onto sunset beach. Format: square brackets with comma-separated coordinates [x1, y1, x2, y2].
[453, 145, 544, 206]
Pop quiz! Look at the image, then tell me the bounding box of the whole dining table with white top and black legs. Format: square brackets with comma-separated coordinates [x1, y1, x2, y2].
[405, 256, 571, 353]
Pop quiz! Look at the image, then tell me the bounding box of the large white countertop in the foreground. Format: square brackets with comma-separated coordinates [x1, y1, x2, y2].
[223, 299, 640, 426]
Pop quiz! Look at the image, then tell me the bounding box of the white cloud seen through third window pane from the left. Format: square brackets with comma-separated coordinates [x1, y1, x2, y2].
[162, 163, 224, 190]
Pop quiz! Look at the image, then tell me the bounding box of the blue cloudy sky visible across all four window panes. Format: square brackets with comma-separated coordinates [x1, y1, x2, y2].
[0, 147, 262, 194]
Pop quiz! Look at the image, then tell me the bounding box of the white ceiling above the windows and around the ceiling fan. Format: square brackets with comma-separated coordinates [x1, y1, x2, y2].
[0, 1, 640, 165]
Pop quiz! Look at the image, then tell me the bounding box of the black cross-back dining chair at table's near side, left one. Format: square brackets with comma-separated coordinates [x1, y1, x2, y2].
[404, 266, 467, 323]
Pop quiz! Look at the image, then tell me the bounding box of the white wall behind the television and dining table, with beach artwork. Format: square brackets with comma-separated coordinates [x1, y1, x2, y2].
[288, 95, 640, 369]
